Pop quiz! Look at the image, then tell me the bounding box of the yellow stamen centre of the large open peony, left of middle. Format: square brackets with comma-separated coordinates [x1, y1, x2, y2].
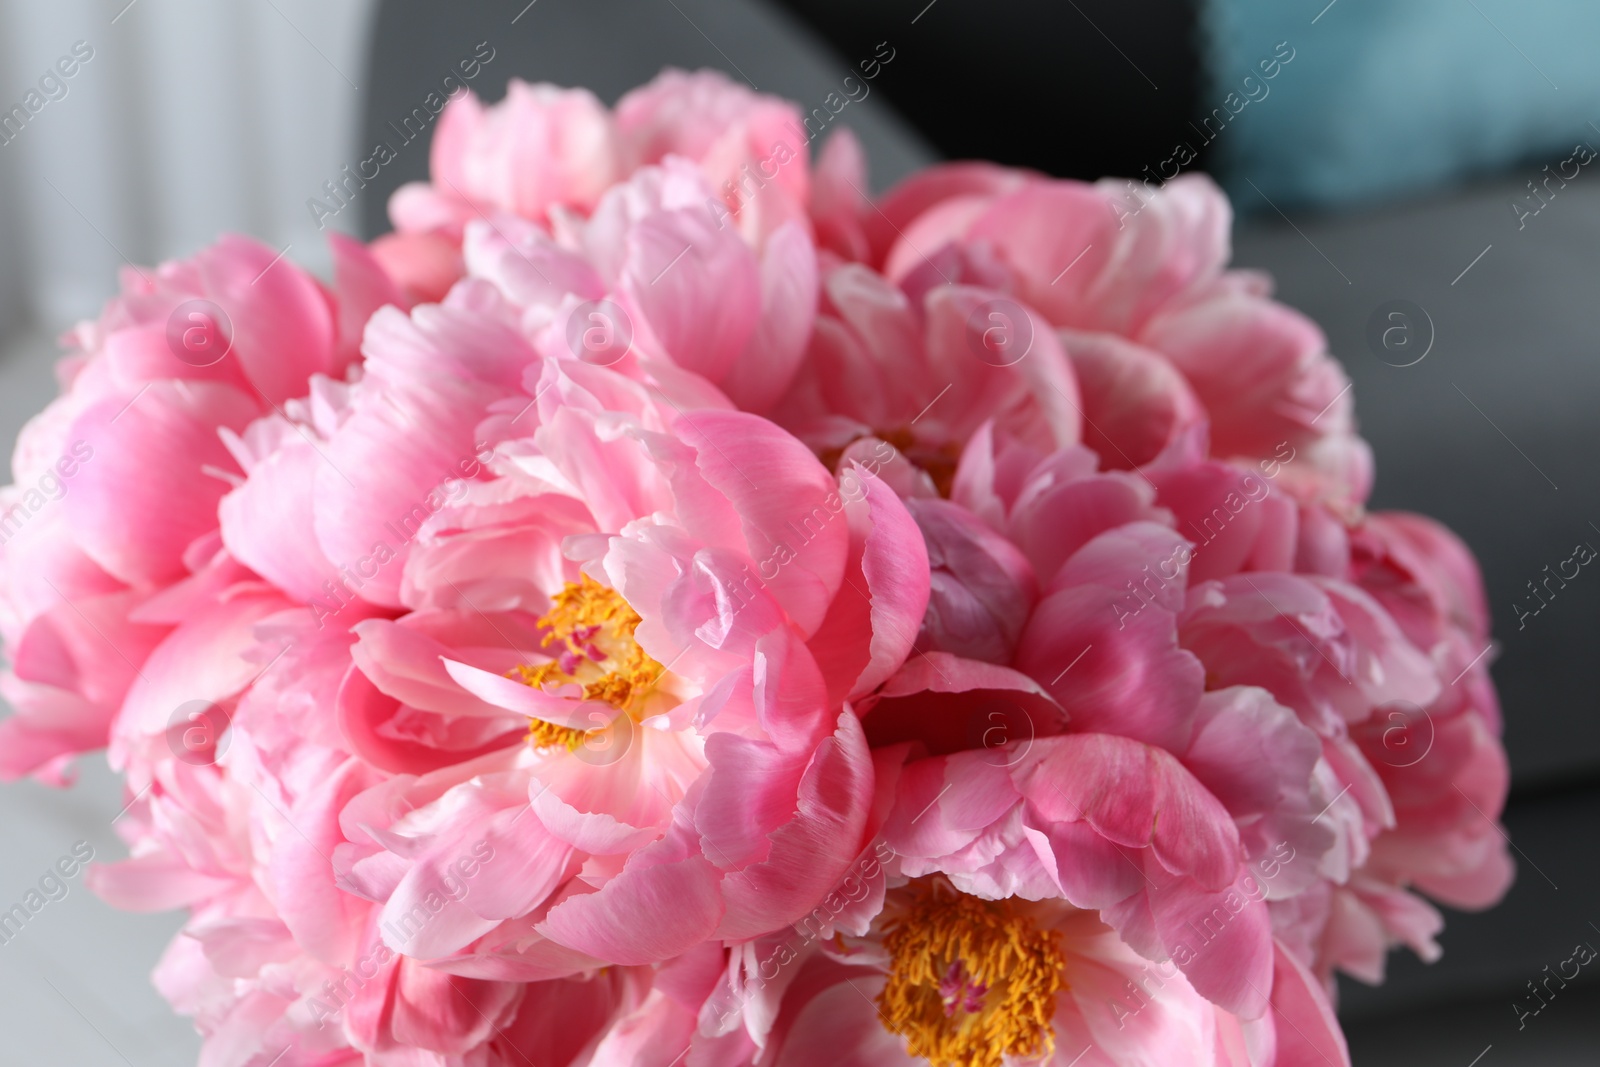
[507, 574, 666, 749]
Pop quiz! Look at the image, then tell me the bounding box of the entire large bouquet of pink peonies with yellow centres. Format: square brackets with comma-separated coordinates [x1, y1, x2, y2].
[0, 72, 1512, 1067]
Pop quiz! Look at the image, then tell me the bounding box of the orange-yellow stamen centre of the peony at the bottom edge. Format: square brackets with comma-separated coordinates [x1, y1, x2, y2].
[878, 878, 1066, 1067]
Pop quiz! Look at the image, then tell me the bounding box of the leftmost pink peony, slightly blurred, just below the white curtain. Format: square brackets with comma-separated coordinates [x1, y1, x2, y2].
[0, 237, 395, 777]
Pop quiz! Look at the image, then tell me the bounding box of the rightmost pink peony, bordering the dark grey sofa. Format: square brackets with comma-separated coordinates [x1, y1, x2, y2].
[1164, 515, 1512, 982]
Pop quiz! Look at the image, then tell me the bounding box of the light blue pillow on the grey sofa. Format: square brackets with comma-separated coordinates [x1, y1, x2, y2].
[1195, 0, 1600, 211]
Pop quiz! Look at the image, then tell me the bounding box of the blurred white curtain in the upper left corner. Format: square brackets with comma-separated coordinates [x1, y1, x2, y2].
[0, 0, 374, 340]
